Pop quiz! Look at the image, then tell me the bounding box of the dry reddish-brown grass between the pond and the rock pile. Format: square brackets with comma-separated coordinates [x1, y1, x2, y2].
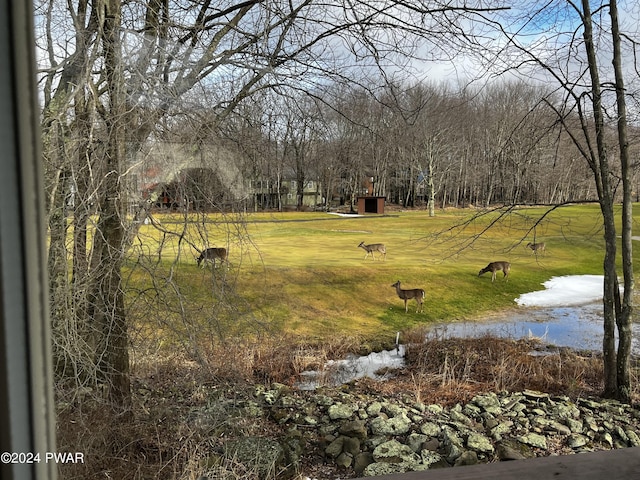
[368, 336, 603, 405]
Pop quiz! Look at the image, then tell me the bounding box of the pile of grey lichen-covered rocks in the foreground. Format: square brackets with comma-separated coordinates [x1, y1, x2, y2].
[257, 385, 640, 476]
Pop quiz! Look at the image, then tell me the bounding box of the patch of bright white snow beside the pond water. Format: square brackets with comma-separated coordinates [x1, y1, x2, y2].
[516, 275, 604, 307]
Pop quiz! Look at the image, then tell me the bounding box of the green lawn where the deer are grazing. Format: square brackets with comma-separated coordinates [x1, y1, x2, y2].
[129, 205, 632, 352]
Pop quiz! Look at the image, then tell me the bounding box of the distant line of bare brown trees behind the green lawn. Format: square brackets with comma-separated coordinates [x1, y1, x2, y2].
[208, 81, 624, 213]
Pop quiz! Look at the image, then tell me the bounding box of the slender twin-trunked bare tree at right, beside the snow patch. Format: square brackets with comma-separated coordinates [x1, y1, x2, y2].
[482, 0, 637, 401]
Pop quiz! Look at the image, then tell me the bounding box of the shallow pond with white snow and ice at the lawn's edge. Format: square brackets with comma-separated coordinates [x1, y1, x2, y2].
[298, 275, 640, 390]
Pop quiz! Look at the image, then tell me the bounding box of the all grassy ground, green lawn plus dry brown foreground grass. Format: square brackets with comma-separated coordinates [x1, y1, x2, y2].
[56, 202, 638, 479]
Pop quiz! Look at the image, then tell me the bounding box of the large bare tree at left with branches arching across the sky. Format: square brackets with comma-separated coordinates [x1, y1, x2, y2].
[37, 0, 510, 407]
